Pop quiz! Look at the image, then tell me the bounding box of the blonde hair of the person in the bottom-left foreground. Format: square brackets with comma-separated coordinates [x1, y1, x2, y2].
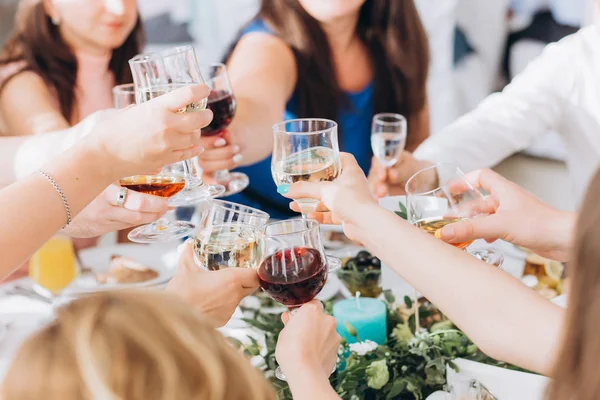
[0, 291, 275, 400]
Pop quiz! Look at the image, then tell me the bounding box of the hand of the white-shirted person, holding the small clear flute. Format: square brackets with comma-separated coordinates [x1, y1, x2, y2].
[369, 151, 433, 198]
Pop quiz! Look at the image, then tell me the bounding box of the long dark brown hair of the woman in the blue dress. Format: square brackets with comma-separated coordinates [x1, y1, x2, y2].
[233, 0, 429, 147]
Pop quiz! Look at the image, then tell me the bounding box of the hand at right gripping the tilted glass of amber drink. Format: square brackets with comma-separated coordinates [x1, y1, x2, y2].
[441, 169, 575, 261]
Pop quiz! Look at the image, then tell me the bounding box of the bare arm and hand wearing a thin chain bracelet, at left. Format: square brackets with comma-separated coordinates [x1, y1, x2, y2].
[0, 85, 212, 279]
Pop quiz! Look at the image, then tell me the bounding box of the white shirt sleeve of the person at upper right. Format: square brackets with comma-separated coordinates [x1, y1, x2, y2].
[414, 34, 580, 171]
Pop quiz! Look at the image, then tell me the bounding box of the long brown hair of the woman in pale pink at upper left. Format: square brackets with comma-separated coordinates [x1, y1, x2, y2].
[0, 1, 144, 120]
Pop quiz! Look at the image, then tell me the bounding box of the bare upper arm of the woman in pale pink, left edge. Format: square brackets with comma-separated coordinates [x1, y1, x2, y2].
[0, 71, 69, 136]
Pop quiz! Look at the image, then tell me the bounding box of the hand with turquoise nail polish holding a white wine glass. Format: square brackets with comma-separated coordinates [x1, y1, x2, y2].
[283, 153, 377, 240]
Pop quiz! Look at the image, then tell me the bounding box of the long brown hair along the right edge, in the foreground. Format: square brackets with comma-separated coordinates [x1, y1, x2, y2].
[548, 171, 600, 400]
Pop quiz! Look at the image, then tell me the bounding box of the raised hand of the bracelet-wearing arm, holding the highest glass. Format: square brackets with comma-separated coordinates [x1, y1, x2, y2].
[80, 85, 212, 177]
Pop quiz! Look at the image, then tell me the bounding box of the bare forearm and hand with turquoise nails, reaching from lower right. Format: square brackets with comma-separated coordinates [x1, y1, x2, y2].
[285, 153, 564, 374]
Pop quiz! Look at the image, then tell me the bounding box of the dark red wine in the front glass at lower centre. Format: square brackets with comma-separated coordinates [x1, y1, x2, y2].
[258, 247, 327, 308]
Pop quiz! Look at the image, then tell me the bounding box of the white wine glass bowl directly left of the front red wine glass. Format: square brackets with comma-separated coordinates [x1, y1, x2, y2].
[194, 200, 270, 271]
